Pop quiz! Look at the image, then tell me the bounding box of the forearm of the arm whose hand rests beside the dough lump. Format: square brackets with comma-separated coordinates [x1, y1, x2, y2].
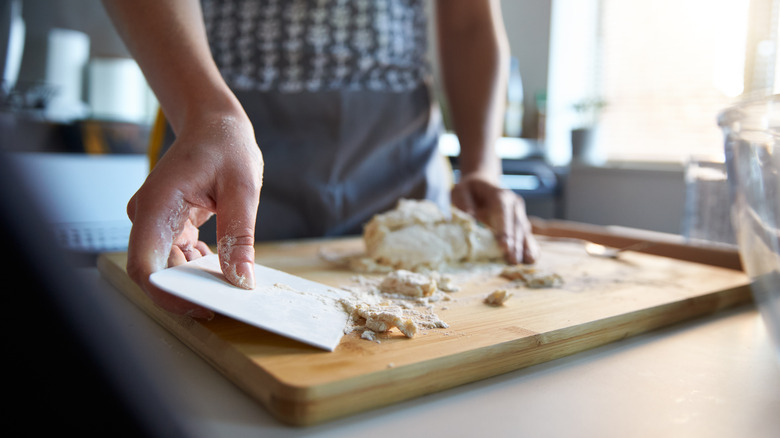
[436, 0, 509, 182]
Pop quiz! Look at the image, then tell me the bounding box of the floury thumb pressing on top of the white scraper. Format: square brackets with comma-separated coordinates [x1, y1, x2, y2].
[217, 182, 260, 289]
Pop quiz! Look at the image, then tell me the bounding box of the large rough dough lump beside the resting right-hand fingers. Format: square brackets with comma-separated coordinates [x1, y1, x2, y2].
[354, 199, 503, 271]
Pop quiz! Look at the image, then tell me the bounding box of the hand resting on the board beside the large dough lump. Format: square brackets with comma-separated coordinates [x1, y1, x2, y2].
[451, 175, 539, 264]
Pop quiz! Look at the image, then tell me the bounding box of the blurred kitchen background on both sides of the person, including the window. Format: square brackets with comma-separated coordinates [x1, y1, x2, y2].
[0, 0, 780, 252]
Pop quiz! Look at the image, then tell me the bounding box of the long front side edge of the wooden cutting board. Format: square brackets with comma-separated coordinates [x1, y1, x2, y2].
[268, 285, 752, 427]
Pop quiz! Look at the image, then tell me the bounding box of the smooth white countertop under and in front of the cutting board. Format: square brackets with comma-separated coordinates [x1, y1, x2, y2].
[82, 268, 780, 438]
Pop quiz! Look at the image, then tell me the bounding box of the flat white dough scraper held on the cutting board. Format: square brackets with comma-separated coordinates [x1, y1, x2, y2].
[150, 254, 349, 351]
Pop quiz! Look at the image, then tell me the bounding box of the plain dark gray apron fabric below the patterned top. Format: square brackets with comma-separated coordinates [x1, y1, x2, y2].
[244, 82, 449, 240]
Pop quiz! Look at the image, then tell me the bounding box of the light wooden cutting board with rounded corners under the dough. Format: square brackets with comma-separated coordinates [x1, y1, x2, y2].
[98, 224, 751, 425]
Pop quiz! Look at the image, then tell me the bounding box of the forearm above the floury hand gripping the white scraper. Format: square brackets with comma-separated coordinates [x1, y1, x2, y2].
[103, 0, 243, 132]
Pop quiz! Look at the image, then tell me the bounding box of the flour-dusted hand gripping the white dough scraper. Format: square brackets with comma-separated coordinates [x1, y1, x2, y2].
[127, 116, 263, 319]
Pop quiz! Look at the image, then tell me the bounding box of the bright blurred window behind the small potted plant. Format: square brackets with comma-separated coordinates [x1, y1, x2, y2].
[547, 0, 780, 163]
